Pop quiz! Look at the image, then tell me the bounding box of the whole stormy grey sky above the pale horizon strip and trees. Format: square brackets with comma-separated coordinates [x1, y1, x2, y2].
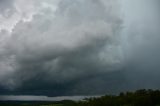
[0, 0, 160, 96]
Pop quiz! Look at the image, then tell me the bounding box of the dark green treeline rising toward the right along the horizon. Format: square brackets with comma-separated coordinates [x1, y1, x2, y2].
[73, 89, 160, 106]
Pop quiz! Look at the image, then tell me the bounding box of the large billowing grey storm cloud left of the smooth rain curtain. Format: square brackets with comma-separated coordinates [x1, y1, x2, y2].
[0, 0, 123, 92]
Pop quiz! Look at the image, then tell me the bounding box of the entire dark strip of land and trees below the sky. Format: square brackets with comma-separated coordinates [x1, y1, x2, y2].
[0, 89, 160, 106]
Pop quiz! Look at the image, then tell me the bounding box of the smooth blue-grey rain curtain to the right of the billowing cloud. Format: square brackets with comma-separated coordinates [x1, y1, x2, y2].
[120, 0, 160, 89]
